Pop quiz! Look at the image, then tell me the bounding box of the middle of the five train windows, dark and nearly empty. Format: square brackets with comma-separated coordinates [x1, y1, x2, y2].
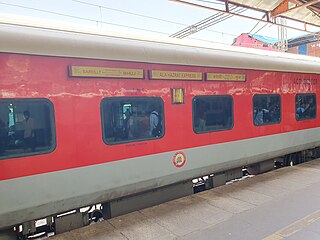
[193, 96, 233, 133]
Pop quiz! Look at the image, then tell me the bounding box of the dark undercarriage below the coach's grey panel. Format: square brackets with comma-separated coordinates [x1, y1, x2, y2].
[0, 147, 320, 240]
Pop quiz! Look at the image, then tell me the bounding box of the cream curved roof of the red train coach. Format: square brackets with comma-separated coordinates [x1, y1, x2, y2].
[0, 16, 320, 74]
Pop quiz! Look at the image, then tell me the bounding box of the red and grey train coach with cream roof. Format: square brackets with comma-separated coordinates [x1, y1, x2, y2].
[0, 23, 320, 238]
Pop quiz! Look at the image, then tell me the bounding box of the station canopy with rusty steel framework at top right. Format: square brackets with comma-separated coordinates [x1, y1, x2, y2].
[171, 0, 320, 33]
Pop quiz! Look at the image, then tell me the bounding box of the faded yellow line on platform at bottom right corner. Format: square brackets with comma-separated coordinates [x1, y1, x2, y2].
[262, 210, 320, 240]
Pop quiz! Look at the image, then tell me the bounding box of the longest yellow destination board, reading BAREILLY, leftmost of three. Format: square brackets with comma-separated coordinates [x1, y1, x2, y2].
[69, 66, 144, 79]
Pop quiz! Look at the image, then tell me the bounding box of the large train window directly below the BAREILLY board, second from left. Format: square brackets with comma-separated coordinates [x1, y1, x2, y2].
[101, 97, 164, 144]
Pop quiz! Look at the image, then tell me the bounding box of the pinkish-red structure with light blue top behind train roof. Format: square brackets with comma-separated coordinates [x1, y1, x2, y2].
[232, 33, 280, 51]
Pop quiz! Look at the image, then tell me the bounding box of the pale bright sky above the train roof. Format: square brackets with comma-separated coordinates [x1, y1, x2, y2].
[0, 0, 316, 45]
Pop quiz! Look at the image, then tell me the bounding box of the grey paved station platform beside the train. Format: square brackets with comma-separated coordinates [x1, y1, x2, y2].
[49, 159, 320, 240]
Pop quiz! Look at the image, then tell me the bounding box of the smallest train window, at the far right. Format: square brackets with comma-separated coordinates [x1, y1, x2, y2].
[296, 94, 317, 120]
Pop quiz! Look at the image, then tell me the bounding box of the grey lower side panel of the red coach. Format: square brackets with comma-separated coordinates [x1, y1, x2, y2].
[0, 128, 320, 229]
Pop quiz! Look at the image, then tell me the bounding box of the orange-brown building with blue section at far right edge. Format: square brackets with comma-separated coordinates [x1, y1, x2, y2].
[287, 32, 320, 57]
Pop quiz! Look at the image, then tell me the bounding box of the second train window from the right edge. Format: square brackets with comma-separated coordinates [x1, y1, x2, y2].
[253, 94, 281, 126]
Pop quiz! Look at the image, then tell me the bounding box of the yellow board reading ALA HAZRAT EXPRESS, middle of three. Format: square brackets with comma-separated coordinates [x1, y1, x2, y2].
[150, 70, 202, 81]
